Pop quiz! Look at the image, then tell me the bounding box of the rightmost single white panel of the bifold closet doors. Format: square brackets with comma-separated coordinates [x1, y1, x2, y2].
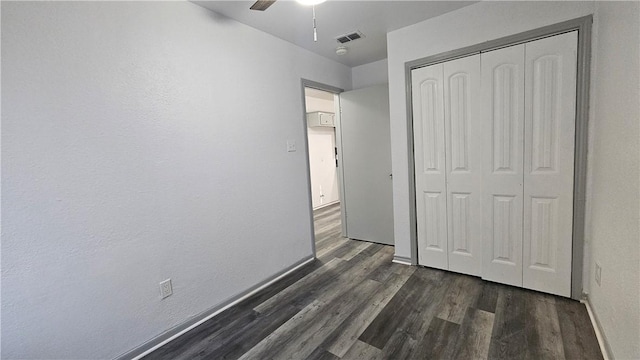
[523, 32, 578, 296]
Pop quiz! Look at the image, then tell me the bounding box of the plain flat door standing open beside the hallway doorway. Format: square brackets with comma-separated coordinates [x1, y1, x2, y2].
[340, 85, 394, 245]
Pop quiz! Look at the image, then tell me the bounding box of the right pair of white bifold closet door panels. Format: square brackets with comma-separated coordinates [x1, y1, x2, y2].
[482, 32, 577, 296]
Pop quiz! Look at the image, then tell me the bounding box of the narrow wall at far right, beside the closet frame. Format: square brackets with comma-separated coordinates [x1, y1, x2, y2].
[587, 2, 640, 359]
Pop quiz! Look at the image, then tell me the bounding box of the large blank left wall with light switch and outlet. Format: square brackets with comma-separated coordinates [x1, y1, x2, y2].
[2, 2, 351, 358]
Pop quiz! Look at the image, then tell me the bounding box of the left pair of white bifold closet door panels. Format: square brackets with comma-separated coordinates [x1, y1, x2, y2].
[412, 55, 482, 275]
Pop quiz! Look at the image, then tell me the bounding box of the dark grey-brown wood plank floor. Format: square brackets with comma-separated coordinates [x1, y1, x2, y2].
[145, 206, 602, 360]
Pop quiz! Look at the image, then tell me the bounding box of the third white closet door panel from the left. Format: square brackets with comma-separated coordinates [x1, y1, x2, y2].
[481, 45, 524, 286]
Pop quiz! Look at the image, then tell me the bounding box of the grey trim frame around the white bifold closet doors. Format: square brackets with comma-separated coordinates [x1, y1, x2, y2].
[403, 15, 593, 300]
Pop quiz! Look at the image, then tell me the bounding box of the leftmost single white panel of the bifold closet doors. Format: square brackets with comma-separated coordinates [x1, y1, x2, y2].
[412, 64, 448, 269]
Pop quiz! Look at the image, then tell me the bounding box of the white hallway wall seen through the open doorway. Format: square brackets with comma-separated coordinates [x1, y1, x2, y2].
[305, 96, 340, 209]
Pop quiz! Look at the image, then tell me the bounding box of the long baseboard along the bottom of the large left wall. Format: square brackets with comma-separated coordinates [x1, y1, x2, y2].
[117, 255, 316, 360]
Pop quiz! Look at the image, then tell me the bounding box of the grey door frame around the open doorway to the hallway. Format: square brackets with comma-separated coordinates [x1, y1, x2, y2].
[300, 79, 346, 258]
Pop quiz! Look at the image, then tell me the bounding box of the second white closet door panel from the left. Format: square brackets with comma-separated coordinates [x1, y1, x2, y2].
[444, 55, 482, 276]
